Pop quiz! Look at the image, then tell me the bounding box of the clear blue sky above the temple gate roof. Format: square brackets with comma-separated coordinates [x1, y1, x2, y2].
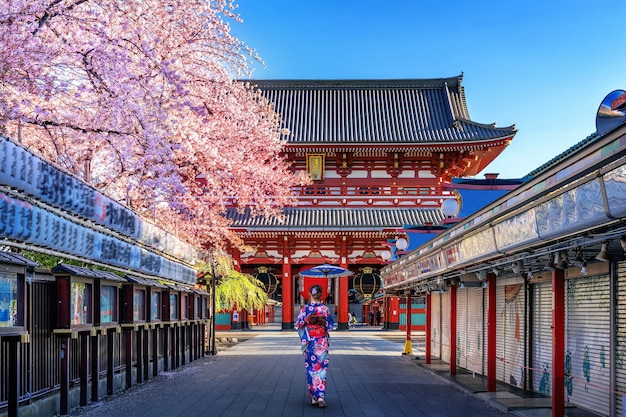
[232, 0, 626, 178]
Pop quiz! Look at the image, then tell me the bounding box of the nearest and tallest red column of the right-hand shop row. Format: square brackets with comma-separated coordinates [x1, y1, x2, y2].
[552, 268, 565, 416]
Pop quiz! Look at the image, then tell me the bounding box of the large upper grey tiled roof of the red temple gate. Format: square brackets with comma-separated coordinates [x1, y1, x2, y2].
[250, 75, 516, 144]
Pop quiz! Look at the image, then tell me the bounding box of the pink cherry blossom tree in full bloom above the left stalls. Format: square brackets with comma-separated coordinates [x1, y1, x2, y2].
[0, 0, 306, 246]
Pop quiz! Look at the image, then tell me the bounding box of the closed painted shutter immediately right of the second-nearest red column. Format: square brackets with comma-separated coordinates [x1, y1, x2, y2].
[496, 283, 526, 388]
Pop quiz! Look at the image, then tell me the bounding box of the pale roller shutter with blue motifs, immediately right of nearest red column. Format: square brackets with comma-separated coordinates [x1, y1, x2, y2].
[565, 275, 611, 415]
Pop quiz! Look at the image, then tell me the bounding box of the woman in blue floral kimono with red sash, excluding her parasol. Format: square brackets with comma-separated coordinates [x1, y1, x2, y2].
[296, 285, 334, 408]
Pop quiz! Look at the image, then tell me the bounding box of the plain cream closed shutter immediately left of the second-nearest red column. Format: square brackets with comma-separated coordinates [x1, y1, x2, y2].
[465, 287, 487, 375]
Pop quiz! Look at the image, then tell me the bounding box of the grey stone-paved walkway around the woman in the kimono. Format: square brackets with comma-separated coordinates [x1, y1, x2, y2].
[70, 325, 596, 417]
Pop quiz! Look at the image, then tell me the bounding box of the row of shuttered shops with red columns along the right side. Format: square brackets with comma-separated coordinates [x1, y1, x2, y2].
[382, 92, 626, 416]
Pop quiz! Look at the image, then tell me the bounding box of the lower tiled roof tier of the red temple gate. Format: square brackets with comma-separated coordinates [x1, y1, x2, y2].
[226, 208, 443, 231]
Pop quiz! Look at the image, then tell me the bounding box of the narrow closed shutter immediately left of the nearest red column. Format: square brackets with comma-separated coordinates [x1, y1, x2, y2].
[530, 281, 552, 396]
